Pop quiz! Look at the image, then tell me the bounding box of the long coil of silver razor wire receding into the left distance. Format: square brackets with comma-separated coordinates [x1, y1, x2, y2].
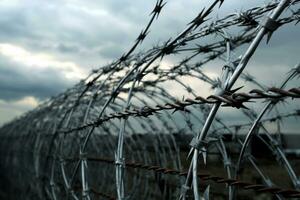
[0, 0, 300, 200]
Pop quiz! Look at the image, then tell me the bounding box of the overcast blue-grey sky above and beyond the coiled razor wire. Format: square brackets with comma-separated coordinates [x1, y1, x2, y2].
[0, 0, 300, 125]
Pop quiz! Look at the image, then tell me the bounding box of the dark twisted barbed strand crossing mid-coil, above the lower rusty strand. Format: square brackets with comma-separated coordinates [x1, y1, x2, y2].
[62, 87, 300, 133]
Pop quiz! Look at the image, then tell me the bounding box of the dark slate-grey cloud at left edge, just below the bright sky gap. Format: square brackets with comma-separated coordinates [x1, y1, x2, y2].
[0, 56, 74, 100]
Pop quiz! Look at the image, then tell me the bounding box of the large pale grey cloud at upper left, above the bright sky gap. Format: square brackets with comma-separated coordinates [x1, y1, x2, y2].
[0, 1, 138, 64]
